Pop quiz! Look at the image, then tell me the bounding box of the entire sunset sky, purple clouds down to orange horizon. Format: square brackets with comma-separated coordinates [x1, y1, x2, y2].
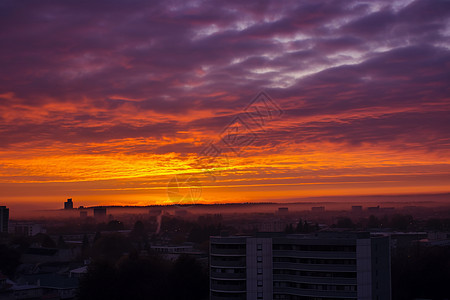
[0, 0, 450, 209]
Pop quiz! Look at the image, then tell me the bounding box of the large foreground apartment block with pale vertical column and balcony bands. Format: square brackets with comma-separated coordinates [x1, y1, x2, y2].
[210, 232, 391, 300]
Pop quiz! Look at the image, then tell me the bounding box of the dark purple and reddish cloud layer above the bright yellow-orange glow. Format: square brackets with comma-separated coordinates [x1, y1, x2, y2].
[0, 0, 450, 153]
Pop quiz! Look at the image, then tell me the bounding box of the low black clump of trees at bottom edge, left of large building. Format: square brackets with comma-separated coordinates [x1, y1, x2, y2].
[78, 255, 209, 300]
